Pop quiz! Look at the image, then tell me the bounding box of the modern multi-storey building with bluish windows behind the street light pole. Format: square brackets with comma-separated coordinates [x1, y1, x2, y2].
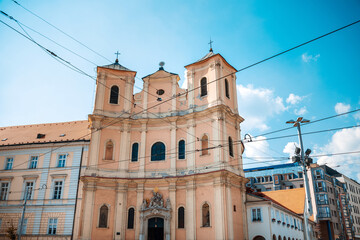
[245, 163, 352, 239]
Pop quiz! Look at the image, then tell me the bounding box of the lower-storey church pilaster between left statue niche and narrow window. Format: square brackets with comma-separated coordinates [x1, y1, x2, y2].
[114, 183, 127, 240]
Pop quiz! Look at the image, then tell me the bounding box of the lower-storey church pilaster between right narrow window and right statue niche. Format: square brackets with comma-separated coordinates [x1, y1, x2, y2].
[185, 180, 196, 239]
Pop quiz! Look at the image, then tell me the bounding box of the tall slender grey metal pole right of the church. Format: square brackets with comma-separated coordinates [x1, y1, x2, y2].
[286, 117, 312, 240]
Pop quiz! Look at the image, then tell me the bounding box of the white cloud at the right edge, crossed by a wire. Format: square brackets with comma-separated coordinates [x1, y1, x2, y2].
[314, 128, 360, 180]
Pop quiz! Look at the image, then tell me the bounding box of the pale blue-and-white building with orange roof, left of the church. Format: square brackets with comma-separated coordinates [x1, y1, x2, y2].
[0, 121, 90, 239]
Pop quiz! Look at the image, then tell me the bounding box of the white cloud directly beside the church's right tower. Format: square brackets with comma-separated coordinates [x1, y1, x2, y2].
[236, 84, 287, 131]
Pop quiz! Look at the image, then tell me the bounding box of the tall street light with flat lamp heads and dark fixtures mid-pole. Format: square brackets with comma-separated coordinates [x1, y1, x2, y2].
[286, 117, 312, 240]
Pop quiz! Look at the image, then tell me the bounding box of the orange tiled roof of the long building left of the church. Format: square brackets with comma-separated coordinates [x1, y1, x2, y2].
[0, 120, 90, 147]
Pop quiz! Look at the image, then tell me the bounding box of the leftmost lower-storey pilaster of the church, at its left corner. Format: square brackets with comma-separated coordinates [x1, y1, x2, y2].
[81, 182, 96, 240]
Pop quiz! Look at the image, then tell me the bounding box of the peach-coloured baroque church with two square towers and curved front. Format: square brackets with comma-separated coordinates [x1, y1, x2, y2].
[74, 49, 247, 240]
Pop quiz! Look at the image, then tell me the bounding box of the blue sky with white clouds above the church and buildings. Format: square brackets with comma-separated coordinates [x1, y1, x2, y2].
[0, 0, 360, 180]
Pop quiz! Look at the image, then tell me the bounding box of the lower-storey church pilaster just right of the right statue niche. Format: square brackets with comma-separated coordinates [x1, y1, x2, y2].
[214, 177, 226, 239]
